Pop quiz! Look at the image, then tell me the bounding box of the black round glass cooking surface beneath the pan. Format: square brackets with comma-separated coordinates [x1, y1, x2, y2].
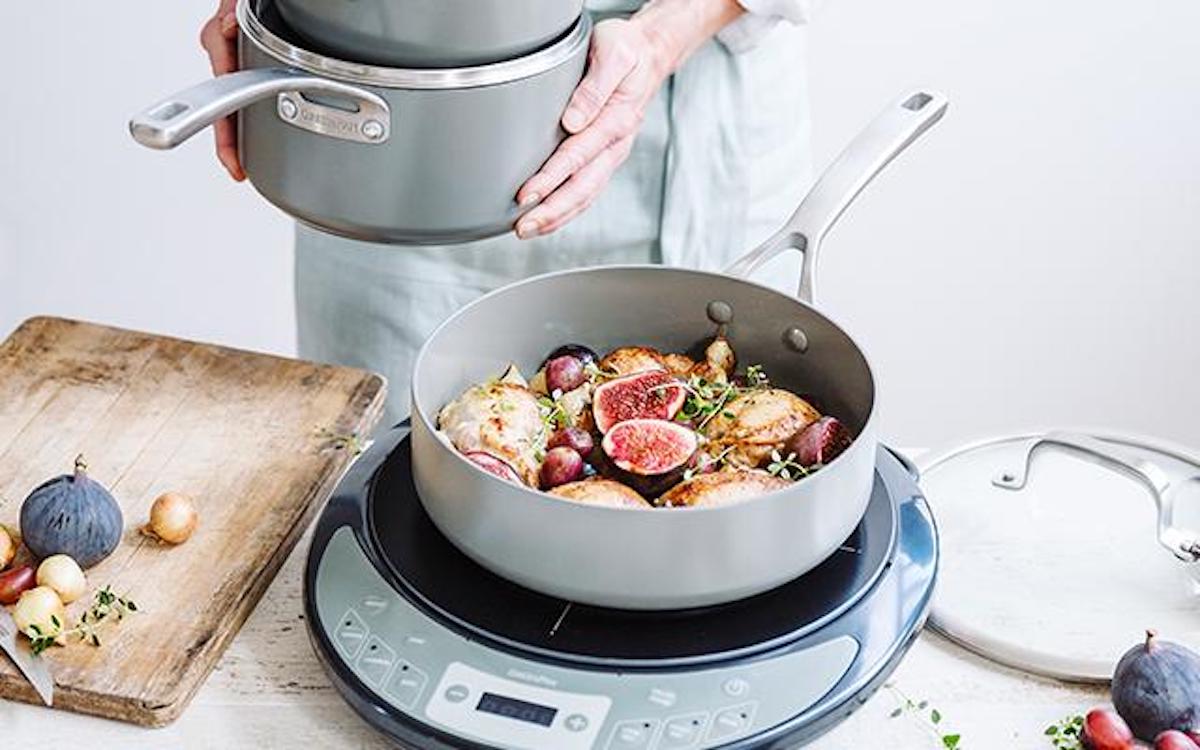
[368, 439, 901, 667]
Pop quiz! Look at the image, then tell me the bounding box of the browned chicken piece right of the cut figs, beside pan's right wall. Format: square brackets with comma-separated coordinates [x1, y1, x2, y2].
[704, 388, 821, 467]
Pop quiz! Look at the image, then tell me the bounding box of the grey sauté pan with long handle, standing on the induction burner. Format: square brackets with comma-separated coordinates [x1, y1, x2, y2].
[413, 92, 947, 610]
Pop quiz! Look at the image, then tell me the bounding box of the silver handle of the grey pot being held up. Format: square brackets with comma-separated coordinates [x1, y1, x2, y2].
[130, 68, 391, 149]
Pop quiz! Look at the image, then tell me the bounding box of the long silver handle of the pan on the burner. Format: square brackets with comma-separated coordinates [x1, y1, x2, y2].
[725, 91, 949, 304]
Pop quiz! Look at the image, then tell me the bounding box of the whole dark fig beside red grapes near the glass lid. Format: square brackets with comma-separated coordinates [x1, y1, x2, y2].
[1112, 630, 1200, 742]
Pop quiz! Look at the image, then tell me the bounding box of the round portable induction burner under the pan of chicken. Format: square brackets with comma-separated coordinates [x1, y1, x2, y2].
[305, 425, 938, 750]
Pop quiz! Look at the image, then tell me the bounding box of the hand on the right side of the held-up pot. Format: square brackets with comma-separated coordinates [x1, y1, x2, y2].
[516, 17, 671, 239]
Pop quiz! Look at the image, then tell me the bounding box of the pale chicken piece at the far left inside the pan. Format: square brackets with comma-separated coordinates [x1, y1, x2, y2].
[438, 380, 546, 487]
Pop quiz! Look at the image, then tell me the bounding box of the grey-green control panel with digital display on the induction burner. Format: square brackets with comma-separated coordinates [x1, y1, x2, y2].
[316, 527, 859, 750]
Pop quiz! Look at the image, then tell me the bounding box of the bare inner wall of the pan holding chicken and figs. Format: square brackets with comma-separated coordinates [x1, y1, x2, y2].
[413, 266, 875, 434]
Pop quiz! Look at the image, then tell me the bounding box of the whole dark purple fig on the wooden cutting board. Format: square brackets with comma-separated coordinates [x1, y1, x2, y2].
[20, 456, 125, 568]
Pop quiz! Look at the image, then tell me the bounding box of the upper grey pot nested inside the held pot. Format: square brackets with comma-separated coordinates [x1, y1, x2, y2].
[278, 0, 583, 67]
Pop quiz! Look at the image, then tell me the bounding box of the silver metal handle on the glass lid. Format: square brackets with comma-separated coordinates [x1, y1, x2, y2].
[991, 432, 1200, 563]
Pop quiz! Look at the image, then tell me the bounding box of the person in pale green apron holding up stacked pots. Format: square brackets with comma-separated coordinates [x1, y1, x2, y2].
[200, 0, 811, 425]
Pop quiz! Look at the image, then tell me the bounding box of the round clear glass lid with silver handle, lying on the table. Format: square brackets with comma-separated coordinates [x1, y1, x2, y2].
[920, 432, 1200, 682]
